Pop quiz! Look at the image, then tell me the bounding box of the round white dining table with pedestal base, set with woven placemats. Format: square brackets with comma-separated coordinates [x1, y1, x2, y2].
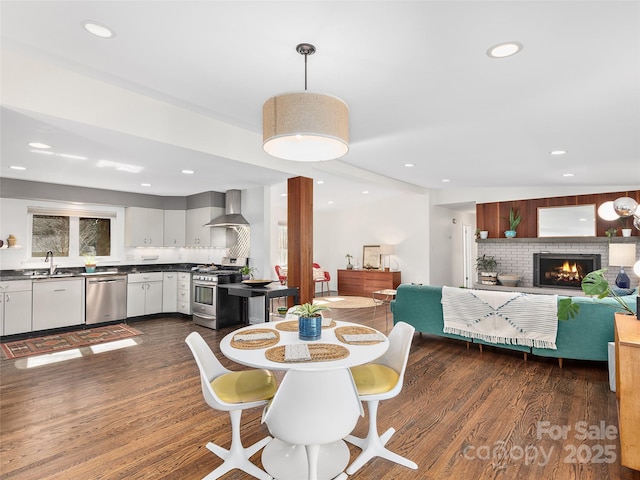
[220, 320, 389, 480]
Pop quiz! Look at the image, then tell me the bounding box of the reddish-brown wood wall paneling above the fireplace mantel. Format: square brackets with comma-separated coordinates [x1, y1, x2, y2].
[476, 190, 640, 238]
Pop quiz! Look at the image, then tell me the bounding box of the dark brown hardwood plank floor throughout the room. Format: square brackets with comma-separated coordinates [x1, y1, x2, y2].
[0, 302, 640, 480]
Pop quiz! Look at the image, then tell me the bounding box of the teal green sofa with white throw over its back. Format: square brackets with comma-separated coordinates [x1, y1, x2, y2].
[391, 284, 636, 366]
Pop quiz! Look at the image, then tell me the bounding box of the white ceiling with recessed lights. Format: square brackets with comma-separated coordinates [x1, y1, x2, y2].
[0, 0, 640, 210]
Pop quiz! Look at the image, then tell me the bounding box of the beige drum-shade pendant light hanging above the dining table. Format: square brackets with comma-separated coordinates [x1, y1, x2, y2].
[262, 43, 349, 162]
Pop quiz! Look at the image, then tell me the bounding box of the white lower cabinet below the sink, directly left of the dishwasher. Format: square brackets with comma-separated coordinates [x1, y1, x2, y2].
[32, 278, 84, 331]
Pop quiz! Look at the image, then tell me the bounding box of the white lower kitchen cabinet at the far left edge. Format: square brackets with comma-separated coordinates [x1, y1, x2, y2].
[0, 280, 31, 335]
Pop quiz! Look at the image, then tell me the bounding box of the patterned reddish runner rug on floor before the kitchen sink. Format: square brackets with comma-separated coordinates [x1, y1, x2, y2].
[0, 323, 142, 359]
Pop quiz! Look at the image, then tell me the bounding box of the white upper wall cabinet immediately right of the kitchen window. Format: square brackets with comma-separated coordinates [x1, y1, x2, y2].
[124, 207, 164, 247]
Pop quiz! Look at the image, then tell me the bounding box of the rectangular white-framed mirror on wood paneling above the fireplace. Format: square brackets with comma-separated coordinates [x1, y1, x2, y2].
[538, 204, 596, 237]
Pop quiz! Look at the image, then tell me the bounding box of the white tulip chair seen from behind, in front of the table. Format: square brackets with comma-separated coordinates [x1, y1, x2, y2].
[262, 368, 364, 480]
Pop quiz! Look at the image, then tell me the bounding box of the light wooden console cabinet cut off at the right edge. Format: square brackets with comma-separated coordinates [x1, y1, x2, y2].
[615, 313, 640, 470]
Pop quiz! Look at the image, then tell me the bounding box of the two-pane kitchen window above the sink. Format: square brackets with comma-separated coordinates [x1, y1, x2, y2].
[28, 207, 116, 258]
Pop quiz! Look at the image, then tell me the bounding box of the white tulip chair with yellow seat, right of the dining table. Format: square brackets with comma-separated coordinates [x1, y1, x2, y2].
[345, 322, 418, 475]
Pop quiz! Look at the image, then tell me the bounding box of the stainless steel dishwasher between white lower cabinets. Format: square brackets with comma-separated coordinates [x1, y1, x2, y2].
[85, 274, 127, 324]
